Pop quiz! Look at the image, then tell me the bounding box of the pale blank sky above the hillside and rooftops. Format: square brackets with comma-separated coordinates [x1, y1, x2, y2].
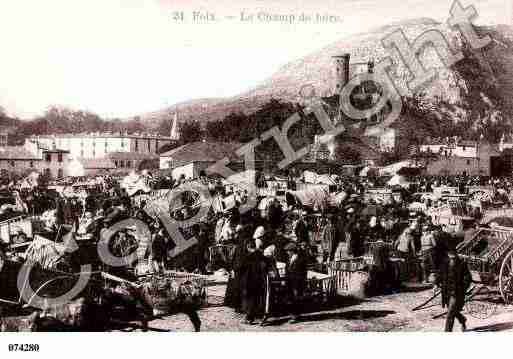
[0, 0, 506, 118]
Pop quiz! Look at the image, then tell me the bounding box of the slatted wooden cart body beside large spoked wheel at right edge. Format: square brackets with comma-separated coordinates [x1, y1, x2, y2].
[457, 227, 513, 304]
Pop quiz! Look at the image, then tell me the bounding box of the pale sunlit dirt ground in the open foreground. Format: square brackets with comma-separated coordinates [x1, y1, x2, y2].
[133, 284, 513, 332]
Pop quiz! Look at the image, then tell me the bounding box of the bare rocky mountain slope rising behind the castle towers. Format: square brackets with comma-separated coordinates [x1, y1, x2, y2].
[141, 18, 513, 139]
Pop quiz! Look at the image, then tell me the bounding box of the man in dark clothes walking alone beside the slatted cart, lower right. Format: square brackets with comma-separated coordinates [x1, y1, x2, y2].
[440, 247, 472, 332]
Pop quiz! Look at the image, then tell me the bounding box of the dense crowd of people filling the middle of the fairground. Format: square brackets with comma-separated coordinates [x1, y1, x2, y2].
[0, 172, 504, 330]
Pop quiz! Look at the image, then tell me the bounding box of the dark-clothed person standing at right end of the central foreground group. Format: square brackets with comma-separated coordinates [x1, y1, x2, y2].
[285, 242, 308, 323]
